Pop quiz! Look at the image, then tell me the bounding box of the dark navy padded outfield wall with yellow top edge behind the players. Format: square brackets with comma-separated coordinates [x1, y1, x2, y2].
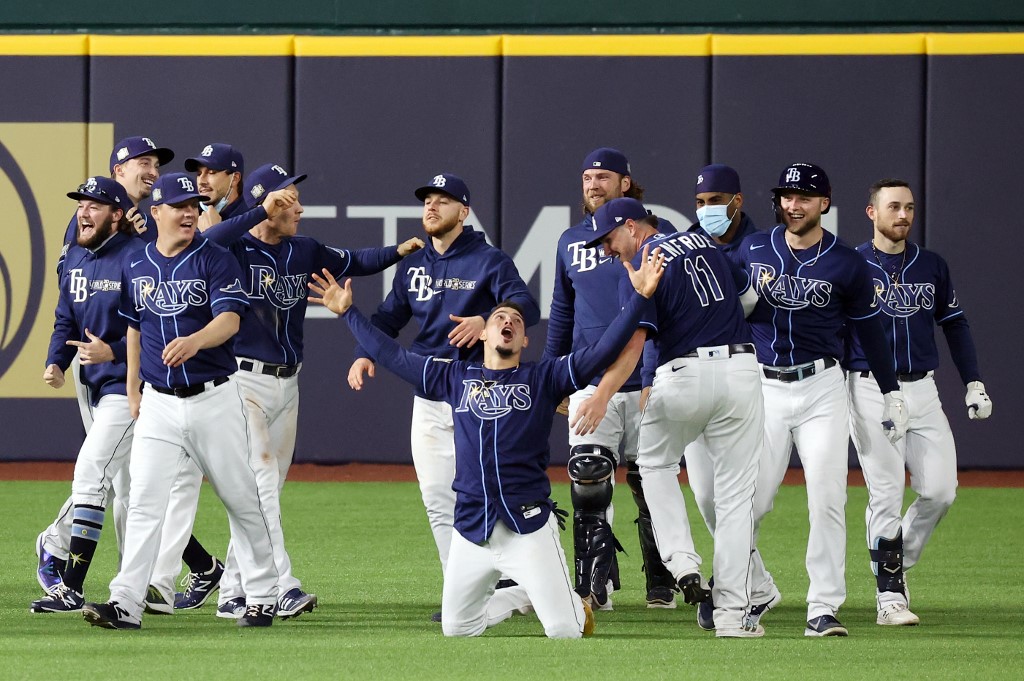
[0, 34, 1024, 468]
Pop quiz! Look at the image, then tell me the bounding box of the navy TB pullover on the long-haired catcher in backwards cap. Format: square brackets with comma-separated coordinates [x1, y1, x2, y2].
[544, 214, 676, 391]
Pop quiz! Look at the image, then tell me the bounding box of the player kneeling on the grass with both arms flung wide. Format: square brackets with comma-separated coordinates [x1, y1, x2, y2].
[310, 242, 664, 638]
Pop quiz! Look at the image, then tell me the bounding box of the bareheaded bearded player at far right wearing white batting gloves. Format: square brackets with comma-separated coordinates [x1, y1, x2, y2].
[845, 179, 992, 626]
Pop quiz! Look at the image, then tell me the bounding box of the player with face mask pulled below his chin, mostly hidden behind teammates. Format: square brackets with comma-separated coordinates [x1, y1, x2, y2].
[146, 142, 248, 612]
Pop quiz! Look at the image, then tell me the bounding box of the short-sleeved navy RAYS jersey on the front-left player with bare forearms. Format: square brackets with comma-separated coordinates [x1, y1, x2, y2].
[119, 238, 249, 388]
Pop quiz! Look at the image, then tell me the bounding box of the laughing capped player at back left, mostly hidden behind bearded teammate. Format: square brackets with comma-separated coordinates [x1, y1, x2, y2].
[36, 137, 174, 591]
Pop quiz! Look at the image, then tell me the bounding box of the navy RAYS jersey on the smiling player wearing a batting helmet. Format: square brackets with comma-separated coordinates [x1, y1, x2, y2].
[738, 225, 878, 367]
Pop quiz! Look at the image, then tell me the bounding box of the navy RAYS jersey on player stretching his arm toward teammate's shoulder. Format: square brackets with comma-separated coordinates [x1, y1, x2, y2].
[230, 235, 401, 365]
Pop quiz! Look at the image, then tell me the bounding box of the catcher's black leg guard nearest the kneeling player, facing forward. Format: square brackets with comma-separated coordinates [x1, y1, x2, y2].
[568, 444, 622, 607]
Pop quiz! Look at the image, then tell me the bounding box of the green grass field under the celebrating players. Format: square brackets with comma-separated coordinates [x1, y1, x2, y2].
[0, 482, 1024, 681]
